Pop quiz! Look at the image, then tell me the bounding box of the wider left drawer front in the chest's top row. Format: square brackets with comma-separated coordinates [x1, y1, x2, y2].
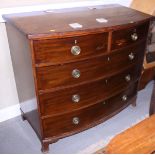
[33, 33, 108, 64]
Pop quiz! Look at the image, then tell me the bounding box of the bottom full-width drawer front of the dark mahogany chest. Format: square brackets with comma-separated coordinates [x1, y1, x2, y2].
[42, 84, 137, 137]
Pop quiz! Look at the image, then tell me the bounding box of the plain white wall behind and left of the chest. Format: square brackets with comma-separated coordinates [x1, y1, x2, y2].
[0, 0, 132, 110]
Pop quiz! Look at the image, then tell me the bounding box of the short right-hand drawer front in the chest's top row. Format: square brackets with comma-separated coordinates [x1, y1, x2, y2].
[111, 22, 149, 50]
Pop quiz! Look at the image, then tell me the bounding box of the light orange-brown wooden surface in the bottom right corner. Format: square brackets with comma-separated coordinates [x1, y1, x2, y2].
[104, 115, 155, 154]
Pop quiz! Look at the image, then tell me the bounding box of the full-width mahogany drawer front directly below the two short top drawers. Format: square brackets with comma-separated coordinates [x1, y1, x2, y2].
[36, 42, 144, 90]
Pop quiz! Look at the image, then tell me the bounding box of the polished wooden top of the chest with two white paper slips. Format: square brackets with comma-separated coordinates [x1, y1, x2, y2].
[3, 4, 151, 38]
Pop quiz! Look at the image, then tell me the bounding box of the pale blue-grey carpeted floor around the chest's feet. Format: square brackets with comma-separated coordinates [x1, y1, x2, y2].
[0, 82, 153, 154]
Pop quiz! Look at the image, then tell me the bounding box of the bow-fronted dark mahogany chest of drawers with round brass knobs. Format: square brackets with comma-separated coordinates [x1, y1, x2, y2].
[4, 5, 152, 151]
